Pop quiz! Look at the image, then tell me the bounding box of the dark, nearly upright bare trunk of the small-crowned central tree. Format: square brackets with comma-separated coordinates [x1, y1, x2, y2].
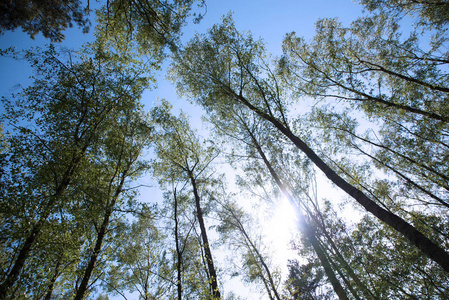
[189, 172, 221, 299]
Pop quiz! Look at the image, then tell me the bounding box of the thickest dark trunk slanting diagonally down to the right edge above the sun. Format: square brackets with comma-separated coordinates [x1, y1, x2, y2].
[228, 89, 449, 272]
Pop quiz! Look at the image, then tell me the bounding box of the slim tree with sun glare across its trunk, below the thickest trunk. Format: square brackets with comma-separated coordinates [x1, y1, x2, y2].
[205, 100, 357, 299]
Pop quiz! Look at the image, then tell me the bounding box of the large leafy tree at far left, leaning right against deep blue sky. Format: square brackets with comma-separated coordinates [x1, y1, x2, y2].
[0, 45, 148, 298]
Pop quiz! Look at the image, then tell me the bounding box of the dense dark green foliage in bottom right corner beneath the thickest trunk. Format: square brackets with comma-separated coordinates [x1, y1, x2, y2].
[348, 212, 448, 299]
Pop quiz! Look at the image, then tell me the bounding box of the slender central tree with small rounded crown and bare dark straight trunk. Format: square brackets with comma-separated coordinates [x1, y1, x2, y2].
[151, 102, 220, 299]
